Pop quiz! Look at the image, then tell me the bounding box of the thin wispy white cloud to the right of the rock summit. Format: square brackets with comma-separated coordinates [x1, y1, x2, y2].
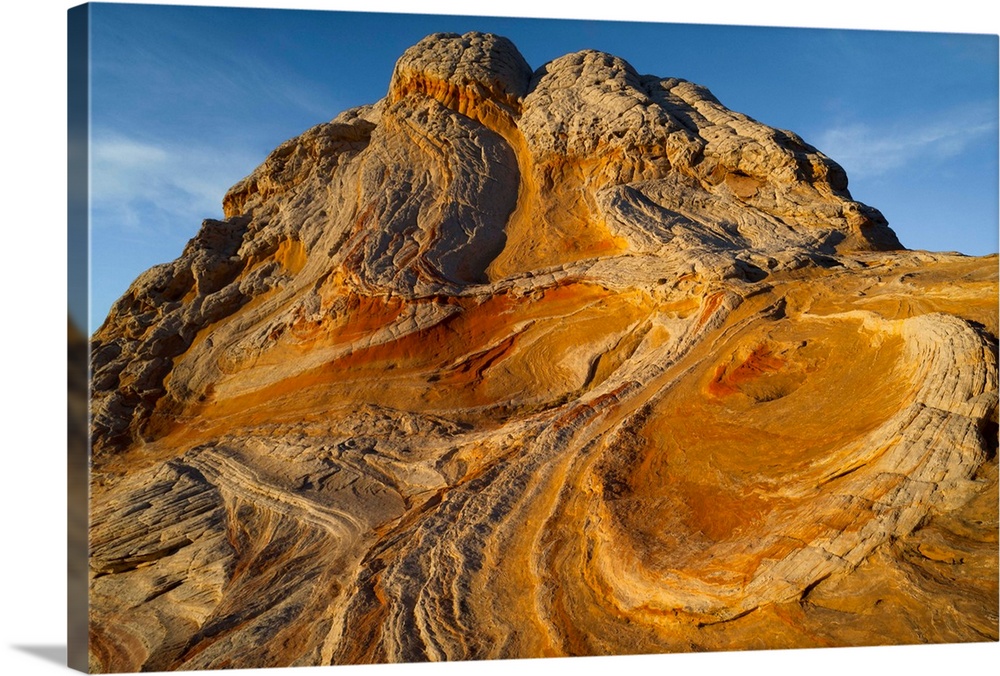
[815, 105, 997, 178]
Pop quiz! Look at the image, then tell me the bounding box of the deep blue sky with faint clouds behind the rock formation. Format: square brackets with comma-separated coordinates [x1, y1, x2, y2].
[82, 4, 998, 330]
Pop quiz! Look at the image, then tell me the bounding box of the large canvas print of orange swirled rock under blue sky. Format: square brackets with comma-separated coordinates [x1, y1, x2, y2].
[70, 3, 998, 673]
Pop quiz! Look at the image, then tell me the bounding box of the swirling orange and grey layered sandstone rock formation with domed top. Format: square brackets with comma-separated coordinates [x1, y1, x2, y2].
[90, 34, 998, 671]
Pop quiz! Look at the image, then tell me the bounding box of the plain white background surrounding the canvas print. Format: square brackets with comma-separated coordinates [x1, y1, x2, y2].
[0, 0, 1000, 676]
